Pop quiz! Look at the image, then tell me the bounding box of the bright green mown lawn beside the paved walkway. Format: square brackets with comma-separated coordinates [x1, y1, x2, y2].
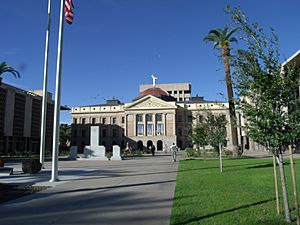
[171, 158, 300, 225]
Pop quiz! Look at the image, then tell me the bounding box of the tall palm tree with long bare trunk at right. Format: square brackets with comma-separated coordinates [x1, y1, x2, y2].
[203, 26, 239, 157]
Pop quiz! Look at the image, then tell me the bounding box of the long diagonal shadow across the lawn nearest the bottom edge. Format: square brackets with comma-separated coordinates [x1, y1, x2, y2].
[172, 198, 279, 225]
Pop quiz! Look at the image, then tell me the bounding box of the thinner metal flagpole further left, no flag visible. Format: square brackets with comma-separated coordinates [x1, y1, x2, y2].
[40, 0, 51, 168]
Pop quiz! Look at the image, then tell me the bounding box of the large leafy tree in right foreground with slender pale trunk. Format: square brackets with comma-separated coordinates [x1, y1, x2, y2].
[228, 8, 300, 222]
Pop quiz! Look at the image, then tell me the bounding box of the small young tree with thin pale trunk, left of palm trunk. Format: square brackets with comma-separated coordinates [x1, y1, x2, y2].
[206, 111, 227, 172]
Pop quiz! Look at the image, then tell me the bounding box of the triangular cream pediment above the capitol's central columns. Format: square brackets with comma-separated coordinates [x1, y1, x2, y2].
[125, 95, 177, 109]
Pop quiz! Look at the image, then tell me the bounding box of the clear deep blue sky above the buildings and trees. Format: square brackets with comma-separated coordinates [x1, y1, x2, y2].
[0, 0, 300, 123]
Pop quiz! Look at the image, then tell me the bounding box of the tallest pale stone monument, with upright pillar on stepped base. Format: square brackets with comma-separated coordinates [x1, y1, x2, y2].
[84, 126, 108, 160]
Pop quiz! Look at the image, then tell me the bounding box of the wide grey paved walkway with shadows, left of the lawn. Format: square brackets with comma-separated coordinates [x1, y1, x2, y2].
[0, 156, 178, 225]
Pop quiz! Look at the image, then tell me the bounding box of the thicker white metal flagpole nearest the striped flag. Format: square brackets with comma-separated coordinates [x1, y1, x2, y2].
[50, 0, 65, 182]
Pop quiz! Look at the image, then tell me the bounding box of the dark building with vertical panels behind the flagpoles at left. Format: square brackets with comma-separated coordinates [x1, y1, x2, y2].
[0, 83, 54, 155]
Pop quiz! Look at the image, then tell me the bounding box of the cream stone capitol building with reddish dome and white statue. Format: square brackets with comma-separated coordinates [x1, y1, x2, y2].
[72, 79, 237, 151]
